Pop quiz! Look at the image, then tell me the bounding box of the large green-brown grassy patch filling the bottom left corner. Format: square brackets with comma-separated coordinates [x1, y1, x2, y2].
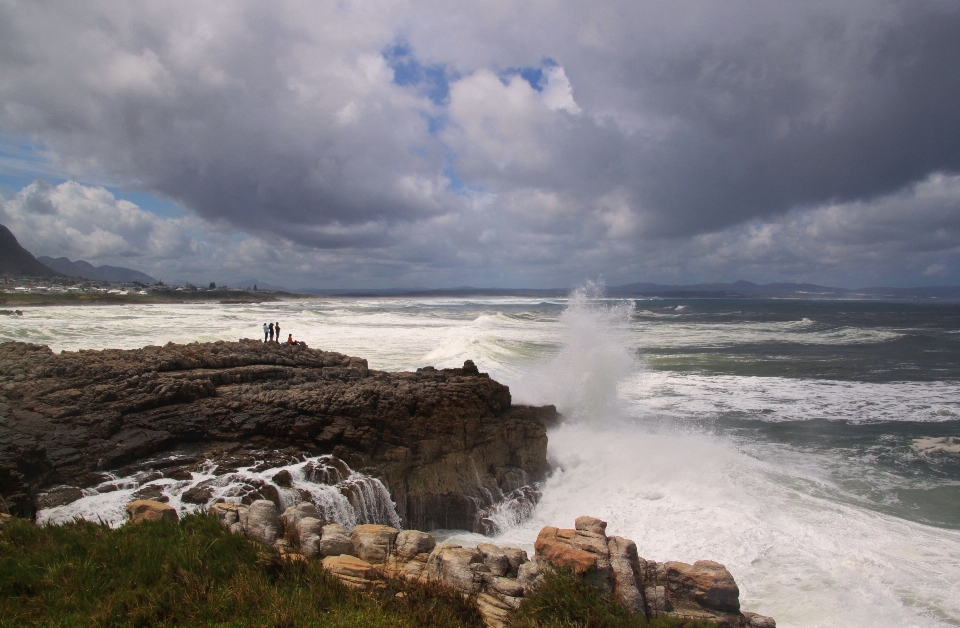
[0, 515, 483, 628]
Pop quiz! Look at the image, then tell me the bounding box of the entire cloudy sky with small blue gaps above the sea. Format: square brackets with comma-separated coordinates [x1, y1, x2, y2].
[0, 0, 960, 288]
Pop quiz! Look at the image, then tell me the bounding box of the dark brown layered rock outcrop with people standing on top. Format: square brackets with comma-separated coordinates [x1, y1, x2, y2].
[0, 340, 557, 531]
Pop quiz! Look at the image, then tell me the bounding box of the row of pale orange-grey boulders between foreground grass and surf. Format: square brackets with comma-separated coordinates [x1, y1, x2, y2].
[142, 500, 776, 628]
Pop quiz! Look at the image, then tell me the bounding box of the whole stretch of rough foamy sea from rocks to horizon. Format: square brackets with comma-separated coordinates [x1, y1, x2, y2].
[0, 286, 960, 627]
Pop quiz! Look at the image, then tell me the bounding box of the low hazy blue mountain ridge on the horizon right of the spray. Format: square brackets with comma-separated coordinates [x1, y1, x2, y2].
[607, 279, 960, 299]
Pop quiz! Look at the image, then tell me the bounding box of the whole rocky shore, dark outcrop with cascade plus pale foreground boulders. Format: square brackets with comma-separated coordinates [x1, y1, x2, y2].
[0, 340, 775, 628]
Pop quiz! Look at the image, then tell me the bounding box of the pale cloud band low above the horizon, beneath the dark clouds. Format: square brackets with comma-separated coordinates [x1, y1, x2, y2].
[0, 174, 960, 288]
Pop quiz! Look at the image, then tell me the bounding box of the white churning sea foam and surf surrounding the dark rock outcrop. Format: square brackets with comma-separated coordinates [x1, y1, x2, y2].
[9, 292, 960, 628]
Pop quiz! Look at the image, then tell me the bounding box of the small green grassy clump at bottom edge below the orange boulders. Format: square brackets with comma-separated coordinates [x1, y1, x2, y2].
[511, 571, 715, 628]
